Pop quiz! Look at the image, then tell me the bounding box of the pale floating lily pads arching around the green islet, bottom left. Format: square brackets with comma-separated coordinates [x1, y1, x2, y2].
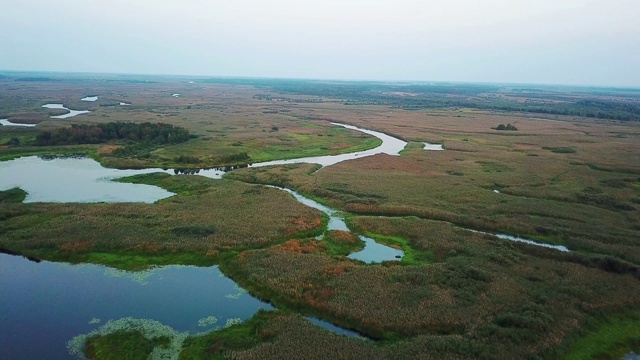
[67, 317, 188, 360]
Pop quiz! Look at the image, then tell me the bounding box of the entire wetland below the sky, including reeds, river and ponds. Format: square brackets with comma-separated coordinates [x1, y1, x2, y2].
[0, 77, 640, 359]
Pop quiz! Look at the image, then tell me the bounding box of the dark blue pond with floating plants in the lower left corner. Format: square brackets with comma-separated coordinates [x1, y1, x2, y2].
[0, 254, 273, 359]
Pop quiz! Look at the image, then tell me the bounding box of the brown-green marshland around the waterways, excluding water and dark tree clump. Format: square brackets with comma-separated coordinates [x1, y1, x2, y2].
[0, 74, 640, 359]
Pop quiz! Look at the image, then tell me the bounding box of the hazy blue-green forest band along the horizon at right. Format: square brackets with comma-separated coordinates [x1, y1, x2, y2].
[204, 79, 640, 121]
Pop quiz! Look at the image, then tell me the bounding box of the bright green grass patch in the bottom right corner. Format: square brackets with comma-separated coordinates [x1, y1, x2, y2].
[564, 312, 640, 360]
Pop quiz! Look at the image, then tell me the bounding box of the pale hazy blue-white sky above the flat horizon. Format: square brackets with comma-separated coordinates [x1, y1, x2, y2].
[0, 0, 640, 87]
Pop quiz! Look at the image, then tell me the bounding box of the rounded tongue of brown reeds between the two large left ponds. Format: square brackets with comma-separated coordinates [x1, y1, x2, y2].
[0, 174, 327, 268]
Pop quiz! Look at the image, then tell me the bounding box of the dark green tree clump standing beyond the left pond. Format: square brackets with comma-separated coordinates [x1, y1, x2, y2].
[36, 122, 190, 146]
